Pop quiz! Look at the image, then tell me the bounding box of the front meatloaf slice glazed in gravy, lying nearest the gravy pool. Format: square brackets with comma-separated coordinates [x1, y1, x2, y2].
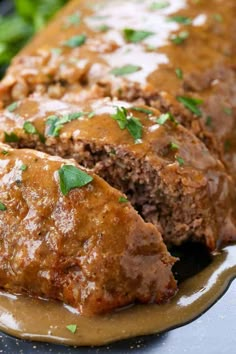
[0, 144, 176, 315]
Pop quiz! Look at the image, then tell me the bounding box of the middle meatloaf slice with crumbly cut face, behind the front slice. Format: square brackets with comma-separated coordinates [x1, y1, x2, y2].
[0, 97, 236, 250]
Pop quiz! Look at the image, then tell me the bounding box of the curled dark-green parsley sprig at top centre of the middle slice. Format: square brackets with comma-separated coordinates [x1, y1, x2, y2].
[111, 107, 143, 143]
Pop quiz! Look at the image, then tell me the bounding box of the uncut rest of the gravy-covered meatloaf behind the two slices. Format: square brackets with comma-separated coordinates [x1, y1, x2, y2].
[0, 0, 236, 176]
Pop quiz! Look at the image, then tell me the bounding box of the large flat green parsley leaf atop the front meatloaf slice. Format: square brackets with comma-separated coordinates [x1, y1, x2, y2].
[58, 165, 93, 195]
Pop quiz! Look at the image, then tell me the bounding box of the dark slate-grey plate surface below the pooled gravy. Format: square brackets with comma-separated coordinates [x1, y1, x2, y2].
[0, 0, 236, 354]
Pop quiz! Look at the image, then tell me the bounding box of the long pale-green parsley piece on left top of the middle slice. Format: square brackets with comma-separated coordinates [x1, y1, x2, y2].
[46, 112, 95, 137]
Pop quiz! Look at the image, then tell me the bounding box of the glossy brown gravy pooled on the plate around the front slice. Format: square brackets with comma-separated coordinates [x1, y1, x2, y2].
[0, 245, 236, 346]
